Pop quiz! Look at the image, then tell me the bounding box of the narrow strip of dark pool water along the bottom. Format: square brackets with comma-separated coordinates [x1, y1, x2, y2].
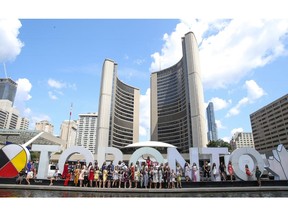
[0, 189, 288, 198]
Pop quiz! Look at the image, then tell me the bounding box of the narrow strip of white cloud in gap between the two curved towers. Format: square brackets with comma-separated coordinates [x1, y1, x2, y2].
[139, 88, 150, 141]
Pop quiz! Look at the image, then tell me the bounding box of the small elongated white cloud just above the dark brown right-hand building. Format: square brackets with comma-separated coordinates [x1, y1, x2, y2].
[226, 80, 266, 118]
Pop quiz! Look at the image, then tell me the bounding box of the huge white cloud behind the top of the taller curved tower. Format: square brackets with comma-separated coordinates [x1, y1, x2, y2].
[150, 19, 288, 88]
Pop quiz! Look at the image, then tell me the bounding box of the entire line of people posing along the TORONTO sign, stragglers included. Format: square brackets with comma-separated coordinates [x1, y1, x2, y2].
[16, 156, 262, 188]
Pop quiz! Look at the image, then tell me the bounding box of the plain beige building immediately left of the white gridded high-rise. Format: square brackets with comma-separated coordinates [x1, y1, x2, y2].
[60, 120, 78, 148]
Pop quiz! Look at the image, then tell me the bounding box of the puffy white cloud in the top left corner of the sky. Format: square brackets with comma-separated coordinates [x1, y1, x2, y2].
[0, 19, 24, 62]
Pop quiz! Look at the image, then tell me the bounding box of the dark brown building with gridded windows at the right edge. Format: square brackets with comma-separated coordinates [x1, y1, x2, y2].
[250, 94, 288, 155]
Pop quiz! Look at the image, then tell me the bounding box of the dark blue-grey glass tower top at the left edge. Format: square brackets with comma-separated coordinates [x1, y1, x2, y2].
[0, 78, 17, 106]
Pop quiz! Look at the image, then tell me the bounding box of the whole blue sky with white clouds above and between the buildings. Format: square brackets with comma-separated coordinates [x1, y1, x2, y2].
[0, 18, 288, 141]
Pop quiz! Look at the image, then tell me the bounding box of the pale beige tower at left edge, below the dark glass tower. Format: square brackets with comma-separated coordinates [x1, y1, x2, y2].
[0, 100, 20, 129]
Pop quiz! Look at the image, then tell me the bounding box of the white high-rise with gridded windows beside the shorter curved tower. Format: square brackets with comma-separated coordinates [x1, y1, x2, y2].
[76, 113, 98, 154]
